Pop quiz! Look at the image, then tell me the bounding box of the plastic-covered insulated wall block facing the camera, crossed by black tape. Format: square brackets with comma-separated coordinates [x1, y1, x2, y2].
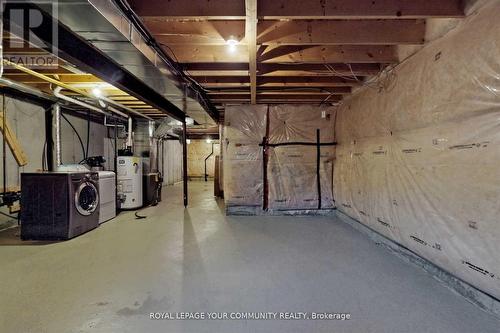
[223, 105, 335, 210]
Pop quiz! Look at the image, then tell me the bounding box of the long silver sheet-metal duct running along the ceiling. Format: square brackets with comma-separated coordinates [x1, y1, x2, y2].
[58, 0, 215, 125]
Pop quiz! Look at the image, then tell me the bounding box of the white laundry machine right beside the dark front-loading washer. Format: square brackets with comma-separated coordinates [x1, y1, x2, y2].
[97, 171, 116, 224]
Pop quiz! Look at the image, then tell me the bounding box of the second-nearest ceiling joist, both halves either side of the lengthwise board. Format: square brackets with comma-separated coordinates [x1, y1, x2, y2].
[144, 18, 425, 47]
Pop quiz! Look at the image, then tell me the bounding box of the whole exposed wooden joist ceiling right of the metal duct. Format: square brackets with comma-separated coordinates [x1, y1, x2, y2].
[128, 0, 464, 105]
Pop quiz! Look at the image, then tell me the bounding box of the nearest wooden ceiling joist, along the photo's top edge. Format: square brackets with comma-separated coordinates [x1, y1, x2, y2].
[128, 0, 464, 20]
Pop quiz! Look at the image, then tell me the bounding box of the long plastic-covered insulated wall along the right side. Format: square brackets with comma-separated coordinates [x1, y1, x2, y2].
[334, 1, 500, 299]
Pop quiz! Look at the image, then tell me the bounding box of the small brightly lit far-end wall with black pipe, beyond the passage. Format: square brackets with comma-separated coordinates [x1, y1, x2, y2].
[187, 140, 220, 180]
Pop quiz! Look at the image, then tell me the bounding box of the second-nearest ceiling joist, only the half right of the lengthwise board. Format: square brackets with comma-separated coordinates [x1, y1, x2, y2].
[257, 20, 425, 45]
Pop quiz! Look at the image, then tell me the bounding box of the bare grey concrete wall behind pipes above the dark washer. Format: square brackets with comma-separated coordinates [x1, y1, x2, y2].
[0, 96, 105, 229]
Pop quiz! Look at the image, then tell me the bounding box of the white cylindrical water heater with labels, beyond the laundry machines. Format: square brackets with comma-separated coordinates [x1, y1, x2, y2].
[117, 156, 143, 209]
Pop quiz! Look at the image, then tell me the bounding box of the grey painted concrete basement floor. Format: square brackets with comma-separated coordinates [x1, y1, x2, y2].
[0, 182, 500, 333]
